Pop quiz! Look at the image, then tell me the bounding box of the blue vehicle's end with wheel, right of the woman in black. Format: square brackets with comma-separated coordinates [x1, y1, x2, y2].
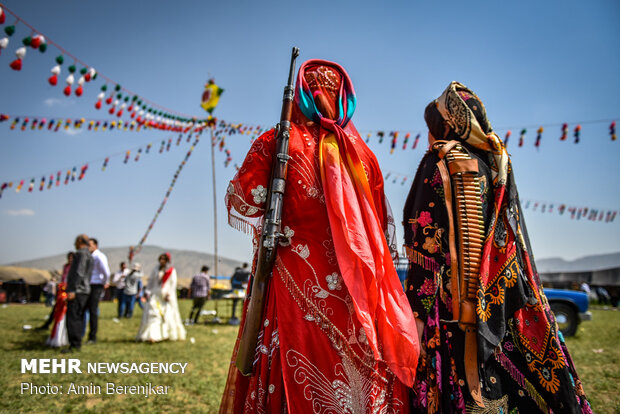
[544, 289, 592, 336]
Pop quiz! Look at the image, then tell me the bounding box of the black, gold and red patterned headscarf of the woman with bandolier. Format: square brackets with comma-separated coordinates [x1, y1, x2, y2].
[425, 82, 566, 393]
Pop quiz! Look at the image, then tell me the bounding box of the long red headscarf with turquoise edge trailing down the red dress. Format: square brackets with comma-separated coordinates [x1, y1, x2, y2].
[295, 60, 419, 386]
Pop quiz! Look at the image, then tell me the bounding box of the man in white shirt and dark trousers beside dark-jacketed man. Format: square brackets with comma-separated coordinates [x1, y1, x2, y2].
[86, 238, 110, 344]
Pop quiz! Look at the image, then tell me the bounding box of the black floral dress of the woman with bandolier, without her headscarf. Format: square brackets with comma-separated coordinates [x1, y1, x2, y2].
[403, 147, 591, 413]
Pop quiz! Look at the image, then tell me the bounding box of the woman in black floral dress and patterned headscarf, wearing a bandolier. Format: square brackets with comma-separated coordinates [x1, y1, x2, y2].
[403, 82, 591, 414]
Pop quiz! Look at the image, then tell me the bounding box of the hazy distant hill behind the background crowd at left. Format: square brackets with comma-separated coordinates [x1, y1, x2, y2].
[10, 246, 249, 286]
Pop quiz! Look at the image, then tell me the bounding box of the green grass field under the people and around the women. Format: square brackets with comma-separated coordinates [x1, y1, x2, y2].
[0, 300, 620, 413]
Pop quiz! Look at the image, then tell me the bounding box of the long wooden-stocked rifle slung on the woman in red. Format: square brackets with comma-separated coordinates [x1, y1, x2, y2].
[236, 47, 299, 376]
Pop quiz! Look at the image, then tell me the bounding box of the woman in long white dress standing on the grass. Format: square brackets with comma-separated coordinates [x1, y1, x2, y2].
[136, 253, 186, 342]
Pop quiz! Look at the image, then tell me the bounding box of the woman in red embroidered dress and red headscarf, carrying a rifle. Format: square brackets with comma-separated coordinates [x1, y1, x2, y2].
[220, 60, 418, 413]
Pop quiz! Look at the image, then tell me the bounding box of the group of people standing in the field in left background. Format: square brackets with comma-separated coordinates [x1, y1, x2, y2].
[32, 234, 249, 353]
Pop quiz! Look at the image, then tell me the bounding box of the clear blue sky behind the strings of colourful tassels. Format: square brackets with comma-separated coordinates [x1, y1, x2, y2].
[0, 0, 620, 270]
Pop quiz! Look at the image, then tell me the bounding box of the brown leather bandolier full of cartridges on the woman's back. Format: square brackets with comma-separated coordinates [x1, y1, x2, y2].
[432, 141, 485, 407]
